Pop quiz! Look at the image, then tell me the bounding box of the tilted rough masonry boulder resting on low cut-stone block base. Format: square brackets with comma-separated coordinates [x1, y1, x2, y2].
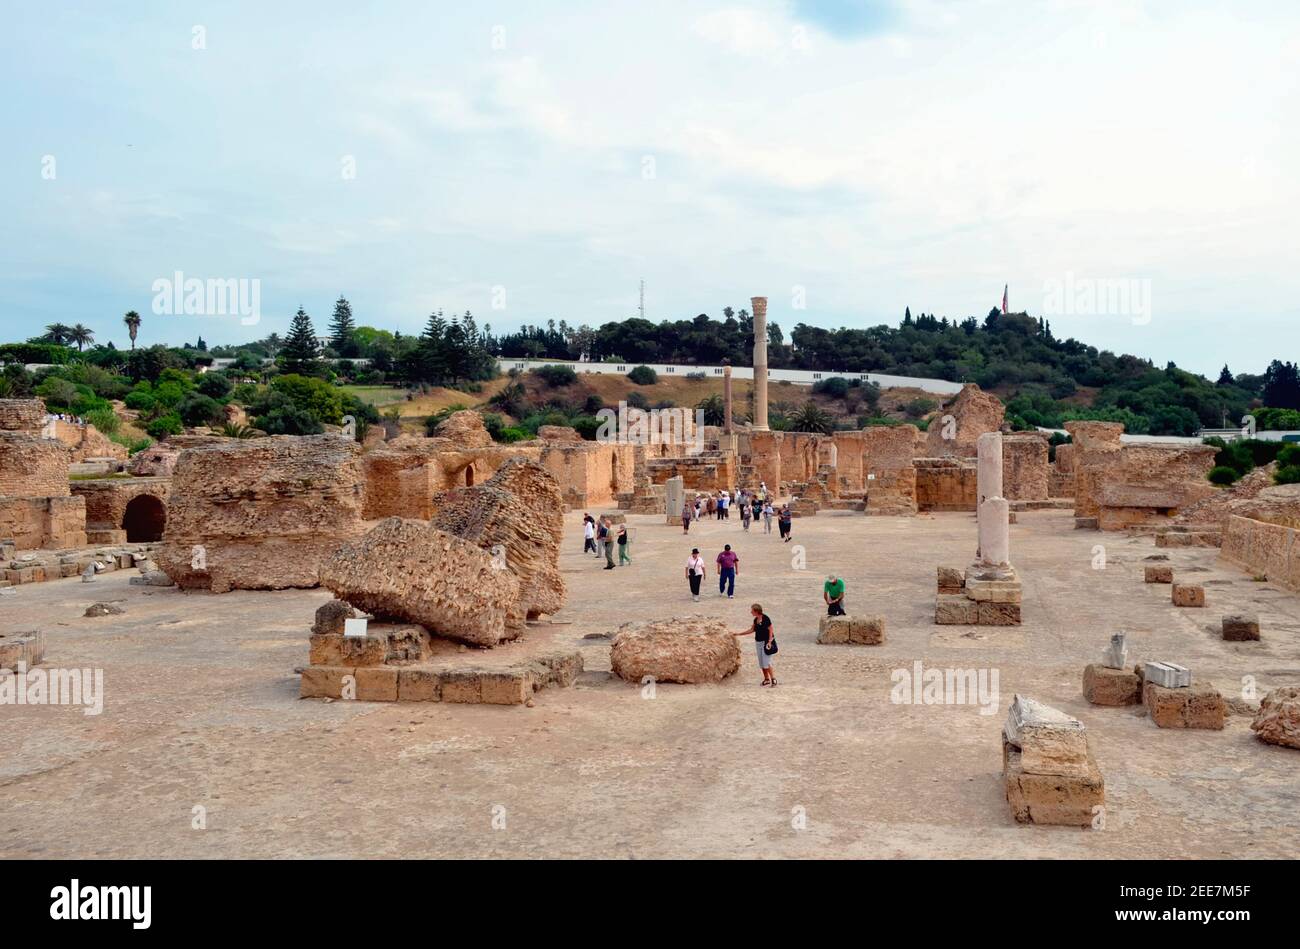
[320, 517, 521, 646]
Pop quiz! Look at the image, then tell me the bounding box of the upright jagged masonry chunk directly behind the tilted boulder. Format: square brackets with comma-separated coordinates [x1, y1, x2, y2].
[432, 458, 567, 627]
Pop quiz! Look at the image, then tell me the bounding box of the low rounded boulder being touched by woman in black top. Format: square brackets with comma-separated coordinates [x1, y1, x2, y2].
[610, 616, 740, 683]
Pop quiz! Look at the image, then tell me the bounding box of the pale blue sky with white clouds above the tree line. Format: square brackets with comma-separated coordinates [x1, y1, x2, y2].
[0, 0, 1300, 377]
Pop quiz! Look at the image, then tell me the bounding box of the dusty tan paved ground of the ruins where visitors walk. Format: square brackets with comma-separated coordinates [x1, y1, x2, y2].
[0, 511, 1300, 858]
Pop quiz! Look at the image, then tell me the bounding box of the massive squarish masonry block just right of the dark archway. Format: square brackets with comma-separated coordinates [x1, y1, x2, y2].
[156, 436, 365, 593]
